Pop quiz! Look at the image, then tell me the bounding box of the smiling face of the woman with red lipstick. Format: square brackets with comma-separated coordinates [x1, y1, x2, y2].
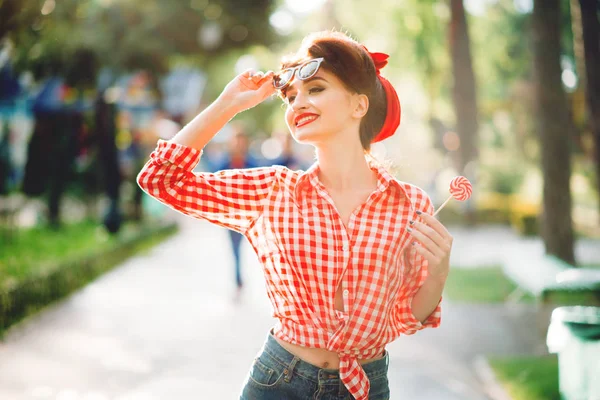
[285, 68, 360, 144]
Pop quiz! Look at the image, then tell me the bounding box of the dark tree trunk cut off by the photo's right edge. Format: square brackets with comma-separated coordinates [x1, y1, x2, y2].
[579, 0, 600, 224]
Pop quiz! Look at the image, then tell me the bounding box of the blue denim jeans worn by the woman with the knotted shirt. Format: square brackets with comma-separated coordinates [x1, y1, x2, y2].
[240, 335, 390, 400]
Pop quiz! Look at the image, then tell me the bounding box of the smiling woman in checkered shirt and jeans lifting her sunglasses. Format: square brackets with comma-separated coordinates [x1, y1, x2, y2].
[138, 32, 452, 400]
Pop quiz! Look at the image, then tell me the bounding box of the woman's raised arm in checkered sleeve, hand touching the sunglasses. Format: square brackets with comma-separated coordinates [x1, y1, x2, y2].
[137, 71, 277, 233]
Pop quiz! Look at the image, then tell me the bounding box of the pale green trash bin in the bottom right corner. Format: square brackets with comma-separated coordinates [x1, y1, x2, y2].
[546, 306, 600, 400]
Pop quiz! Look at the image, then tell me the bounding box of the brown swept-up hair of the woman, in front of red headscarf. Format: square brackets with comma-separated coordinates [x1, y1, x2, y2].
[281, 31, 387, 151]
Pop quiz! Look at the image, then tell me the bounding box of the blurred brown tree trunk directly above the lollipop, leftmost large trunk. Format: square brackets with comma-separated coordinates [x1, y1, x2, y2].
[450, 0, 478, 173]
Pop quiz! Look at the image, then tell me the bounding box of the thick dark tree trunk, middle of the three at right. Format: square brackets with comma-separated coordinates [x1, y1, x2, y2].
[532, 0, 575, 264]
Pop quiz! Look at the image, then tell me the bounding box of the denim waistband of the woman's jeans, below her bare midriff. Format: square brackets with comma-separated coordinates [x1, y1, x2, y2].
[263, 333, 389, 383]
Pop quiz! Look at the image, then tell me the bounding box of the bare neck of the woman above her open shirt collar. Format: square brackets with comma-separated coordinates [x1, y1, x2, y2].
[317, 142, 377, 192]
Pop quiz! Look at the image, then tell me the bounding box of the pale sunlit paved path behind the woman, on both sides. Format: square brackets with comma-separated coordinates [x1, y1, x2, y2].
[0, 211, 544, 400]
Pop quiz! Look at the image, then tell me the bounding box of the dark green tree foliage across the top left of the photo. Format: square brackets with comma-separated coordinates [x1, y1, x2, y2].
[5, 0, 275, 78]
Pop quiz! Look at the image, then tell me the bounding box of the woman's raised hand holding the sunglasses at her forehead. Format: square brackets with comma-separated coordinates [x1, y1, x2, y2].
[219, 70, 275, 112]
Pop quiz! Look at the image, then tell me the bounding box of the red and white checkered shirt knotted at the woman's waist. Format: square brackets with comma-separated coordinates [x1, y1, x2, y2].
[138, 140, 441, 399]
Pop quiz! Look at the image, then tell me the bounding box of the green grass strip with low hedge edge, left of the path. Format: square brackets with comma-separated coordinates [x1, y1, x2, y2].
[0, 221, 176, 333]
